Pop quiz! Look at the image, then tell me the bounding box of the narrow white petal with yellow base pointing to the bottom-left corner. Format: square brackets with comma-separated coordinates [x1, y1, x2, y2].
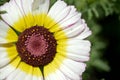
[0, 58, 20, 80]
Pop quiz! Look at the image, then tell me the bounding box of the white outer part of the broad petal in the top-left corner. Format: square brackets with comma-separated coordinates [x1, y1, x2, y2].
[0, 0, 23, 26]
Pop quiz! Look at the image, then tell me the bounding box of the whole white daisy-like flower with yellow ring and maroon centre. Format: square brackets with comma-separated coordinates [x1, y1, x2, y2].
[0, 0, 91, 80]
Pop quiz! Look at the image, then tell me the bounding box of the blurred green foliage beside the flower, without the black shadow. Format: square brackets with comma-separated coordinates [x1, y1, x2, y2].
[0, 0, 120, 80]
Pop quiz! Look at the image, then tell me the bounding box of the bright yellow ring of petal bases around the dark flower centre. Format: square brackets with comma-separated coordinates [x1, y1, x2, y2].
[7, 13, 67, 76]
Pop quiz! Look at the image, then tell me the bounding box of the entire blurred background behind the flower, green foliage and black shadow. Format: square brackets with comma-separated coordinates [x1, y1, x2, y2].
[0, 0, 120, 80]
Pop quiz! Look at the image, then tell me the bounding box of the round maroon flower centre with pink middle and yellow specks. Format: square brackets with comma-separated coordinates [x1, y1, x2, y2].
[16, 26, 57, 66]
